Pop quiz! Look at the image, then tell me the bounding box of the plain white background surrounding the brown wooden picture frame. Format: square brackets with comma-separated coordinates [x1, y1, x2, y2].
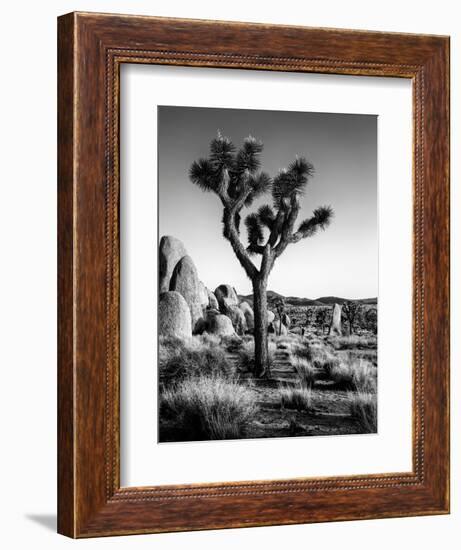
[0, 0, 461, 550]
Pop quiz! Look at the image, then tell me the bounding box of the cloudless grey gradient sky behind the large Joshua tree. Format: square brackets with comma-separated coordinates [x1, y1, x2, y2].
[158, 106, 378, 299]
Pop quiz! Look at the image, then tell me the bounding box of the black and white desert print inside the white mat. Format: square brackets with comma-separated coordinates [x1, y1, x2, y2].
[153, 106, 379, 443]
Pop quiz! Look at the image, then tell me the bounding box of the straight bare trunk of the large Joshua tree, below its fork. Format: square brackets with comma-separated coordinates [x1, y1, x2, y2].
[253, 277, 269, 376]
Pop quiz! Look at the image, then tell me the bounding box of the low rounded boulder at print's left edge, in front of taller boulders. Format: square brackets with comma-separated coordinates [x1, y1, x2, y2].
[158, 291, 192, 338]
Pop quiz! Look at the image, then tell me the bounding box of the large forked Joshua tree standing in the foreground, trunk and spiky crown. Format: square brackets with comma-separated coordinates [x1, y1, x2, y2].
[189, 132, 333, 376]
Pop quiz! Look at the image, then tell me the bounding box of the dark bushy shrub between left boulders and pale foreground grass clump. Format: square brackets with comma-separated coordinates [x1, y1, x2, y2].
[159, 341, 234, 386]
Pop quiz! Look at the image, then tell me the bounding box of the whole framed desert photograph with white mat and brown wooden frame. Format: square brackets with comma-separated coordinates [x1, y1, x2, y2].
[58, 13, 449, 537]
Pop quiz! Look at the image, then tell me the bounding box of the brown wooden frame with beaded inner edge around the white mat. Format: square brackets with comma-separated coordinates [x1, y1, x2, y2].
[58, 13, 449, 537]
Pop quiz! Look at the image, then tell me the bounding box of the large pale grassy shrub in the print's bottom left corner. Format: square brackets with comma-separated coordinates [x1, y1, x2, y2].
[160, 376, 256, 441]
